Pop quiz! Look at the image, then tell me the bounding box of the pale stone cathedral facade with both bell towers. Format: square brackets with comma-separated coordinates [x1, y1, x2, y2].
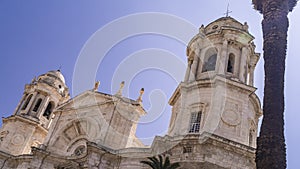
[0, 17, 262, 169]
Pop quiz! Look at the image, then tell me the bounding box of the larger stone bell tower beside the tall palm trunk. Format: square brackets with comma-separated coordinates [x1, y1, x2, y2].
[168, 17, 262, 148]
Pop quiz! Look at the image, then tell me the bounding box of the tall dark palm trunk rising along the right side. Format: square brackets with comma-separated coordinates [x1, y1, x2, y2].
[252, 0, 297, 169]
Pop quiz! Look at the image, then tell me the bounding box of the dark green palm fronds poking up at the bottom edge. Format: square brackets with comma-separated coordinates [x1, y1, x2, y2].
[141, 155, 180, 169]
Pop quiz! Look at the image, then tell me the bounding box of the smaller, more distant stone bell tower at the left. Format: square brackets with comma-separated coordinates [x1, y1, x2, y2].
[0, 70, 70, 155]
